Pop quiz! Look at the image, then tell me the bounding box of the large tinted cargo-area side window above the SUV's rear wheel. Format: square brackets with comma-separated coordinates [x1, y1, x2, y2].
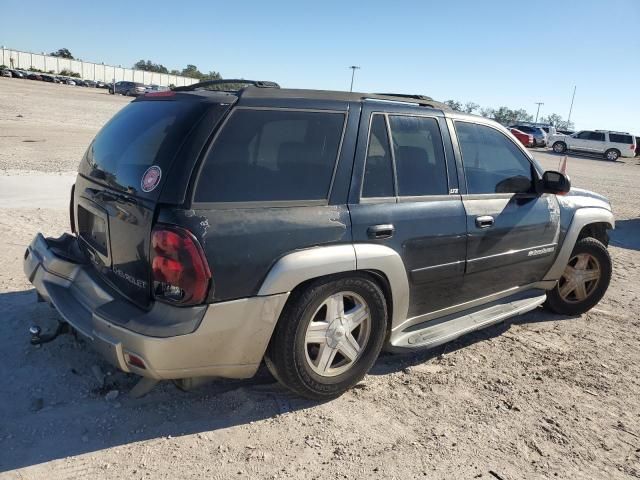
[195, 109, 345, 202]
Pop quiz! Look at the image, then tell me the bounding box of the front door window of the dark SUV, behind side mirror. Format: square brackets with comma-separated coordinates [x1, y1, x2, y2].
[456, 122, 533, 194]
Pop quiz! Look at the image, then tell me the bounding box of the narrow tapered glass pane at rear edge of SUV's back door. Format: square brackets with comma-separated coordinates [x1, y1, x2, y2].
[362, 115, 394, 197]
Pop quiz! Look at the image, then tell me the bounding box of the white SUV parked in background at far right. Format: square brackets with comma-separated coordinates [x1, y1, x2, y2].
[549, 130, 636, 161]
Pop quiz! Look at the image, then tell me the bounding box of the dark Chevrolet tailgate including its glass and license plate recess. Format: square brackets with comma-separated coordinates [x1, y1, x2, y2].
[74, 95, 218, 307]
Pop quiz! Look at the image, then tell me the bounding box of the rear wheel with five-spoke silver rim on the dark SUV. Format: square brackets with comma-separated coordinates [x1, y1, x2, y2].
[265, 275, 387, 401]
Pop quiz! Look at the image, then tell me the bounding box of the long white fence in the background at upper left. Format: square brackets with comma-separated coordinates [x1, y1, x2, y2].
[0, 47, 198, 87]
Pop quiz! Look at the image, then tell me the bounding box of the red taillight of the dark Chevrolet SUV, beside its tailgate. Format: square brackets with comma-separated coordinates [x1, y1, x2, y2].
[151, 225, 211, 305]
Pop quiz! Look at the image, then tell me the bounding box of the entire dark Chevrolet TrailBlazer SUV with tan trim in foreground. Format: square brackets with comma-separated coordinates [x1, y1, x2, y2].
[24, 80, 614, 399]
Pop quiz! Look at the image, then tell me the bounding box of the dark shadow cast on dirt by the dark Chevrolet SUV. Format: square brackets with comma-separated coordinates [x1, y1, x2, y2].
[0, 290, 576, 472]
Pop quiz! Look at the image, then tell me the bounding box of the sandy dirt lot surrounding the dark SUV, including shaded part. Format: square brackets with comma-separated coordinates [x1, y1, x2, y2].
[0, 78, 640, 480]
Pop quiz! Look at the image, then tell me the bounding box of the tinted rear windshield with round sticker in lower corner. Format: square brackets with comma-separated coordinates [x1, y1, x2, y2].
[80, 100, 205, 199]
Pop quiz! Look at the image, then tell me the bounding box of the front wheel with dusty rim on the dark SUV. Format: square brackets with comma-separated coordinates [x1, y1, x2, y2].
[544, 237, 612, 315]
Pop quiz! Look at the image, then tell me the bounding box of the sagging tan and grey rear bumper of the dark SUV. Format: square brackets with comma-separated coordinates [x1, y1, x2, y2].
[24, 234, 288, 380]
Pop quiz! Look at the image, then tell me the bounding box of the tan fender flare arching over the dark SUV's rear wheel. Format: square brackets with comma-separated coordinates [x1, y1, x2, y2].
[258, 243, 409, 328]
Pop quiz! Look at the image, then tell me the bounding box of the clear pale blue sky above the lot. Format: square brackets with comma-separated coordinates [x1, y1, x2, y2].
[0, 0, 640, 134]
